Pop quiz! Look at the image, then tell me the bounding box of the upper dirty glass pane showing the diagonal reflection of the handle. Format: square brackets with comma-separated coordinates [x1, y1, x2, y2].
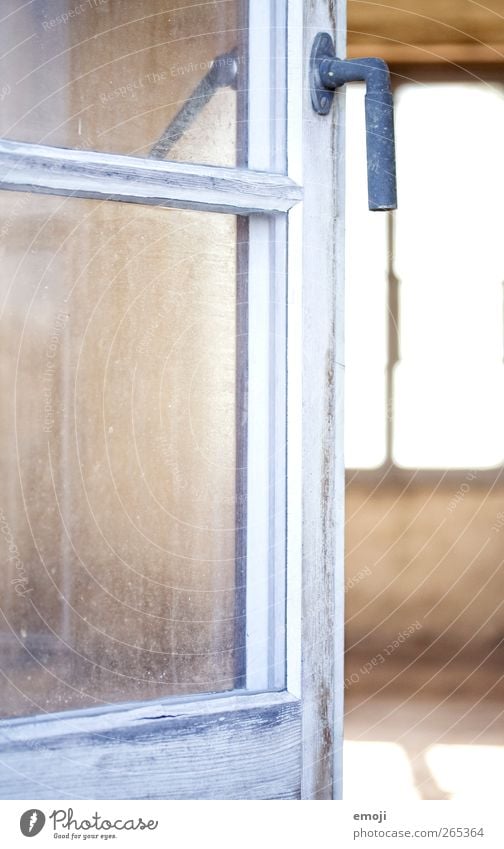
[0, 0, 246, 165]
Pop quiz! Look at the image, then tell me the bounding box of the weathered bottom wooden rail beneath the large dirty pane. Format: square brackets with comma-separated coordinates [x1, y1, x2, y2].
[0, 692, 301, 799]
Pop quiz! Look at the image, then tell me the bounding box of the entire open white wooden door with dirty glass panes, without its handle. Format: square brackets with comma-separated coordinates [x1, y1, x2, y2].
[0, 0, 344, 799]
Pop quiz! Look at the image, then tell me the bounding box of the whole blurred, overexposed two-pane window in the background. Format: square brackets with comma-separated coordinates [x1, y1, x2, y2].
[346, 81, 504, 468]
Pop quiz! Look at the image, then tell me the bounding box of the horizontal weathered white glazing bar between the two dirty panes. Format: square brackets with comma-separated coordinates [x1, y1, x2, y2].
[0, 139, 302, 215]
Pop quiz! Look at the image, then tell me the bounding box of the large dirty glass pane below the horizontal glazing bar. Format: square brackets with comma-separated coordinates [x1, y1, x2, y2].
[0, 192, 243, 716]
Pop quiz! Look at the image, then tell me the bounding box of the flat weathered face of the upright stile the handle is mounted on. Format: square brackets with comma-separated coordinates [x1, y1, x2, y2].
[302, 0, 345, 799]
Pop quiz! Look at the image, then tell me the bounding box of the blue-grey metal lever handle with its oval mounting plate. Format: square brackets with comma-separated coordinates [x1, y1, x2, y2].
[310, 32, 397, 211]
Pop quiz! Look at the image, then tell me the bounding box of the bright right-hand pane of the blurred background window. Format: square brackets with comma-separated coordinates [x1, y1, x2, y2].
[394, 83, 504, 468]
